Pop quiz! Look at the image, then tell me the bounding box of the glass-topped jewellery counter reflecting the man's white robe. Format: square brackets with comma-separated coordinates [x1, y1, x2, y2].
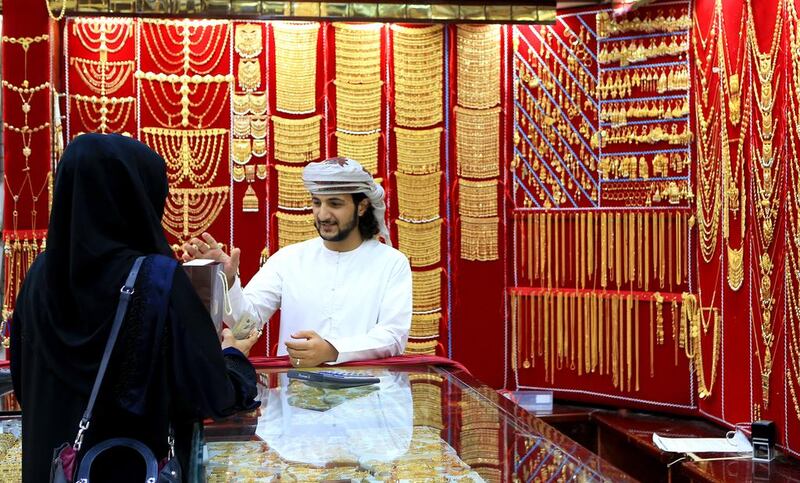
[189, 366, 630, 482]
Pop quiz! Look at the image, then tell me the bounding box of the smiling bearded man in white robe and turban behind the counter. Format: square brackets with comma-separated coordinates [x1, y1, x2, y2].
[183, 158, 412, 367]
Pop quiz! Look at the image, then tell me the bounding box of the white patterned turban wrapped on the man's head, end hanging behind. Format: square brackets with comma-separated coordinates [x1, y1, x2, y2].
[303, 157, 392, 246]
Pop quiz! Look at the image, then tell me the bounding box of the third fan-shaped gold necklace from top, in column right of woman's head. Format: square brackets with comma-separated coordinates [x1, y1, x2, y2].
[141, 127, 228, 188]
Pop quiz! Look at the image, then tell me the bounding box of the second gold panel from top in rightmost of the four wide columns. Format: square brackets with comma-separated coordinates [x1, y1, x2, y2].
[455, 106, 500, 178]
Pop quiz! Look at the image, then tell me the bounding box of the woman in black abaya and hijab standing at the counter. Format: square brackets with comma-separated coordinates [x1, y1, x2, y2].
[11, 134, 258, 482]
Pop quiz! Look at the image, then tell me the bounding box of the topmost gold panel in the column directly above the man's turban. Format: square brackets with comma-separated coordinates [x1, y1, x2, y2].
[333, 22, 383, 84]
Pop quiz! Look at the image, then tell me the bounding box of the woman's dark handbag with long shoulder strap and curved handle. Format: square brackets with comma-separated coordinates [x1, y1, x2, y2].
[50, 257, 182, 483]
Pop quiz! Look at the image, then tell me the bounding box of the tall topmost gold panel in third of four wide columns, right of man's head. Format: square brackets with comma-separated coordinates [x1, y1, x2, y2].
[391, 24, 444, 127]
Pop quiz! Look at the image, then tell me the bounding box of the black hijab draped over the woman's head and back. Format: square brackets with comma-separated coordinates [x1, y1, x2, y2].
[17, 134, 172, 393]
